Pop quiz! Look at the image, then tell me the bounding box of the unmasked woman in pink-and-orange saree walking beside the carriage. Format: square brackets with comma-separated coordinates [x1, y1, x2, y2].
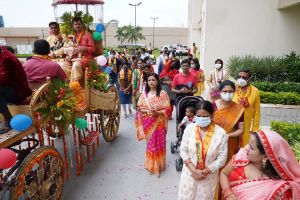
[135, 74, 170, 177]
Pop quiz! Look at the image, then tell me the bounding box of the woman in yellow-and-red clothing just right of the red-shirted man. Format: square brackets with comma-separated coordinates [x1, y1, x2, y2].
[190, 58, 205, 96]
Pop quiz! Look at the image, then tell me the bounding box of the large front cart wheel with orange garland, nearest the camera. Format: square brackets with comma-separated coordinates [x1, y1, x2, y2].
[11, 146, 64, 200]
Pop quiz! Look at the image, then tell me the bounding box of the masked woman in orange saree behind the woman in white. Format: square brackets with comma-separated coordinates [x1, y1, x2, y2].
[213, 80, 244, 161]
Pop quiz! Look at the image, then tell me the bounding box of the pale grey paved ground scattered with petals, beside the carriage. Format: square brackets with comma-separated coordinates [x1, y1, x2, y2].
[63, 111, 180, 200]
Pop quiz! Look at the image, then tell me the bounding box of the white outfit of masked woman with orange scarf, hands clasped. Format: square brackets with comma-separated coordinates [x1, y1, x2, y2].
[178, 123, 228, 200]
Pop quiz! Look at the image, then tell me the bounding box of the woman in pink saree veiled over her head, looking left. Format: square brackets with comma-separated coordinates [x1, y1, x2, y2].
[220, 130, 300, 200]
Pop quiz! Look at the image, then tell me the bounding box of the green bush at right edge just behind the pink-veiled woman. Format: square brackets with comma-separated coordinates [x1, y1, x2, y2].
[271, 121, 300, 160]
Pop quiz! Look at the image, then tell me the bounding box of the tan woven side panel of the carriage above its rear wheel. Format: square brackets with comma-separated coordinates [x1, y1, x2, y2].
[90, 89, 116, 110]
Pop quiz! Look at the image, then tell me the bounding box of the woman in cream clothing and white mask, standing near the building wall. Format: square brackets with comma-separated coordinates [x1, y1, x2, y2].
[207, 59, 229, 102]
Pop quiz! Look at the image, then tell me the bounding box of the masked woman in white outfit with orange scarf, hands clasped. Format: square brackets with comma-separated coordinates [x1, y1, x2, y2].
[178, 101, 228, 200]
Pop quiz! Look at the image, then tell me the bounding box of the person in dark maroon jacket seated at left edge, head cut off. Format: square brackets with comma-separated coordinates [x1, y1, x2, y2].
[0, 46, 31, 134]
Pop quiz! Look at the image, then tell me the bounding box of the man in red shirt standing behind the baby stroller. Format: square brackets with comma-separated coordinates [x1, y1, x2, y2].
[172, 59, 198, 105]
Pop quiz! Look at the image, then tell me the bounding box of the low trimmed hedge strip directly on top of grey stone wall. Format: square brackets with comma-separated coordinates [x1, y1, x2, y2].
[259, 91, 300, 105]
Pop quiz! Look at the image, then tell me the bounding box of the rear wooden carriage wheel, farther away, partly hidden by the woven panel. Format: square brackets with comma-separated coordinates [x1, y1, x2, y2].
[100, 86, 121, 142]
